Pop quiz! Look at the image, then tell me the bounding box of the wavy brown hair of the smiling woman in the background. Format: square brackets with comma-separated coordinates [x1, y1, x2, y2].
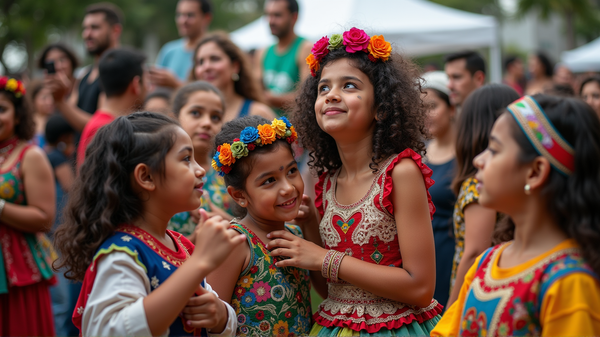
[190, 32, 263, 102]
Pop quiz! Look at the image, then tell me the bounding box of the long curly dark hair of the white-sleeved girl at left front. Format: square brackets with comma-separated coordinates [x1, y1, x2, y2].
[53, 112, 179, 280]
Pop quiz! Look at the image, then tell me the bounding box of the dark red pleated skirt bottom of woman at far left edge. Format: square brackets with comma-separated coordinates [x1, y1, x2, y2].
[0, 281, 55, 336]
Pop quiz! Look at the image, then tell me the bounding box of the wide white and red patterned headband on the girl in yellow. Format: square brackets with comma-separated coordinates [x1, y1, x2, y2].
[508, 96, 575, 175]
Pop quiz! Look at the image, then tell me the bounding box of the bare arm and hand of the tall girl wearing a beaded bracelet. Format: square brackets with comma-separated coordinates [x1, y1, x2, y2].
[268, 159, 435, 307]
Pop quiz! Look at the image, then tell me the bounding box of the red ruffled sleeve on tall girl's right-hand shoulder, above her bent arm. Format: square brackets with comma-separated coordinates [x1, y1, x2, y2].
[377, 149, 435, 219]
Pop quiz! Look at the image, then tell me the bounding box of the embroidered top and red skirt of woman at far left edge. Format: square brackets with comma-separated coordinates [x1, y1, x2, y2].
[0, 146, 56, 336]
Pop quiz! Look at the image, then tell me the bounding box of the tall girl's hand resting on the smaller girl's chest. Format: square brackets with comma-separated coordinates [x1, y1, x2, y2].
[267, 230, 327, 270]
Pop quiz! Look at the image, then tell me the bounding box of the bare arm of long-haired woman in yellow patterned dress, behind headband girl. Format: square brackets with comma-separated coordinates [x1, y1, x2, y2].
[448, 201, 496, 306]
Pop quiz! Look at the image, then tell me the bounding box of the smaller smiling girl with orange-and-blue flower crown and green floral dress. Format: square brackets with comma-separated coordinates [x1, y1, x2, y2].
[207, 116, 318, 336]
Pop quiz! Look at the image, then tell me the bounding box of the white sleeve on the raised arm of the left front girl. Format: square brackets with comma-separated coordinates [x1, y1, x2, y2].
[81, 252, 162, 336]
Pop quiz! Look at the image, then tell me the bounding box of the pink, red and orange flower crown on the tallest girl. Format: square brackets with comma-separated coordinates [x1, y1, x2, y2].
[306, 28, 392, 77]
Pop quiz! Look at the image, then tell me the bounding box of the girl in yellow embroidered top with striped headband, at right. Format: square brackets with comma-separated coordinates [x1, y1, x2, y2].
[433, 95, 600, 336]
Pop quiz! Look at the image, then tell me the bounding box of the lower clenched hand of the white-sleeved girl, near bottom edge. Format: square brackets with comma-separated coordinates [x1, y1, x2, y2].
[183, 287, 228, 334]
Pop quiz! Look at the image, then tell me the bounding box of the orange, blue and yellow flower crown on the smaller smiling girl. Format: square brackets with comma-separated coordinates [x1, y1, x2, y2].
[211, 117, 298, 176]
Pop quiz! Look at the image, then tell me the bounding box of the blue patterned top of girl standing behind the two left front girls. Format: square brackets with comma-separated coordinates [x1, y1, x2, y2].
[168, 168, 234, 236]
